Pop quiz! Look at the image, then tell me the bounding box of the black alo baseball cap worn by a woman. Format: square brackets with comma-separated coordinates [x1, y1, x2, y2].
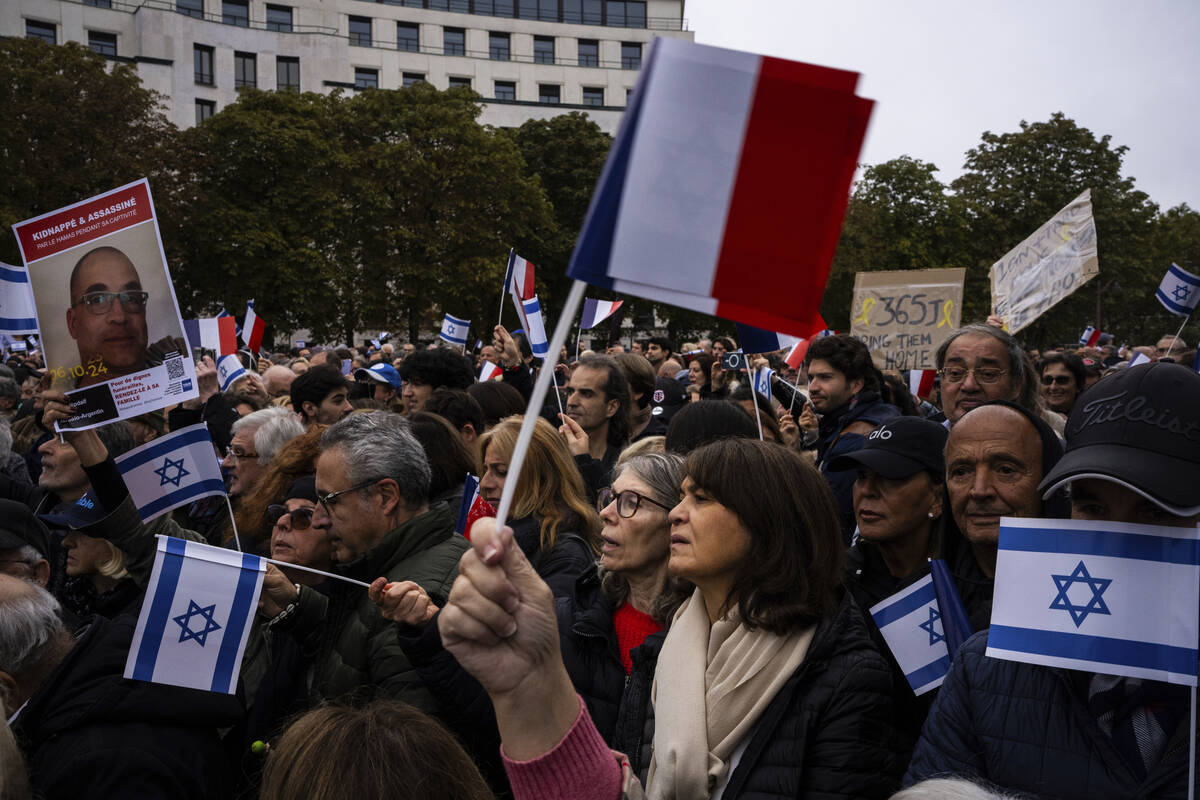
[829, 416, 949, 481]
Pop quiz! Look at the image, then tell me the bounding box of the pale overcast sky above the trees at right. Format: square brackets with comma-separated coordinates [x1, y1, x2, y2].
[684, 0, 1200, 209]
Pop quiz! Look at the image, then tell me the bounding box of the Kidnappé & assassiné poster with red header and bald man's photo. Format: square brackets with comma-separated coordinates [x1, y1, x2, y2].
[13, 179, 198, 429]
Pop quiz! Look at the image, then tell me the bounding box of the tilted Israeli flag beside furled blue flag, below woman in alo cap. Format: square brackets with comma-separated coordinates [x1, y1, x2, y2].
[871, 575, 950, 694]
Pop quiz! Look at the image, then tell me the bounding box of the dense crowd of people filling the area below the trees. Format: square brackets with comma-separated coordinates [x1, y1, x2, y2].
[0, 323, 1200, 800]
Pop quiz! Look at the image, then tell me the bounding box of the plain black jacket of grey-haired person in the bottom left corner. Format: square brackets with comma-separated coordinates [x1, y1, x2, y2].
[13, 616, 241, 800]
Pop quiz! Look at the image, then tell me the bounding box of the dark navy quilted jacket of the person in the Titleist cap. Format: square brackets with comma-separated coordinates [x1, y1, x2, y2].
[905, 631, 1188, 800]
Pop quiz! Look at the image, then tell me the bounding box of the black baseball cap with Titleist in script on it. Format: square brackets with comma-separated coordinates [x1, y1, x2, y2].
[1038, 361, 1200, 517]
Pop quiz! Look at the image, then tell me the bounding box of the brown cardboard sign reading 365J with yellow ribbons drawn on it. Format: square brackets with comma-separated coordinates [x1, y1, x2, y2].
[850, 269, 966, 369]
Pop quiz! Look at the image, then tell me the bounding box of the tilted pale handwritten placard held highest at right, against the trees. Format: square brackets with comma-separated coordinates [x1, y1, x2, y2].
[991, 190, 1100, 333]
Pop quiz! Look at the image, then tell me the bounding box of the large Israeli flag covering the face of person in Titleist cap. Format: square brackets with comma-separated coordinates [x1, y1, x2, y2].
[988, 517, 1200, 686]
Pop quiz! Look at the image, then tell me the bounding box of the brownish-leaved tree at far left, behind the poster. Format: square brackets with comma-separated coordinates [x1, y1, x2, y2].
[0, 38, 174, 264]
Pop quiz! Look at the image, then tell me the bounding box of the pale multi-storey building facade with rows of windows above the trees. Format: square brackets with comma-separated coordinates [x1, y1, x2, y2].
[0, 0, 692, 133]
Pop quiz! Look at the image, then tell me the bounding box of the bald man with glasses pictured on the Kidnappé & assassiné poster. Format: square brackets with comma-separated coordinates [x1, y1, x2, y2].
[65, 246, 149, 386]
